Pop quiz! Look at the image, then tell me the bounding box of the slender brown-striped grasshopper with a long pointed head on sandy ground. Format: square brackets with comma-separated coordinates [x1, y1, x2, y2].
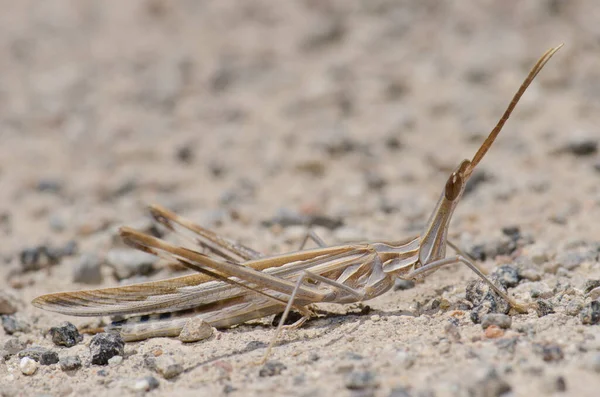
[32, 44, 562, 359]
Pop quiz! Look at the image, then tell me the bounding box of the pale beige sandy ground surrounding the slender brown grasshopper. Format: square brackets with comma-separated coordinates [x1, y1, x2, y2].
[0, 0, 600, 396]
